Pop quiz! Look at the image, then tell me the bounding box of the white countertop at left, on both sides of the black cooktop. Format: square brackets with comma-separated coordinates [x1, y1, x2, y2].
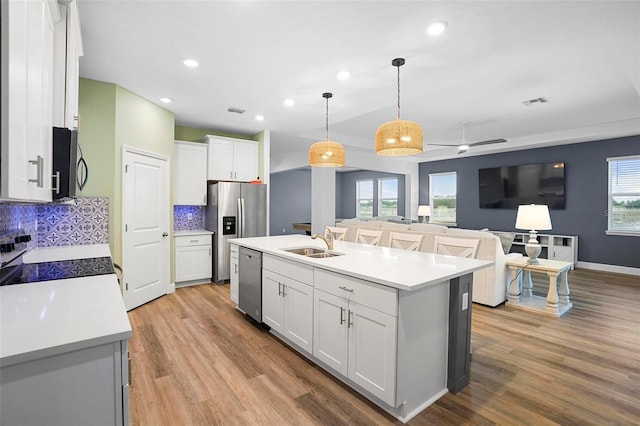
[0, 244, 132, 367]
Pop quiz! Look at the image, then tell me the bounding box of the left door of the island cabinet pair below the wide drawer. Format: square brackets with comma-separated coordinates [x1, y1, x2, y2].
[313, 289, 348, 376]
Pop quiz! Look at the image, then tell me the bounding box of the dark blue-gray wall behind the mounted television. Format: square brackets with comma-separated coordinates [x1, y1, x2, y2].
[419, 136, 640, 268]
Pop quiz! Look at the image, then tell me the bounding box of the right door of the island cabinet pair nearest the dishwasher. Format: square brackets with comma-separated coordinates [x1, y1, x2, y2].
[283, 279, 313, 354]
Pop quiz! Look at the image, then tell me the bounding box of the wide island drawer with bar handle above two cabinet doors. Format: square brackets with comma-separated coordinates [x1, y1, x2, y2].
[313, 268, 398, 317]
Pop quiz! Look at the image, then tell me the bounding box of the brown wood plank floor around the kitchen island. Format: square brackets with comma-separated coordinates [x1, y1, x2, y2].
[129, 269, 640, 426]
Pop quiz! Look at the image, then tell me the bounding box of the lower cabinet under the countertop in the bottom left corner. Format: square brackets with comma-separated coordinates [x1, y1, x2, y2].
[0, 340, 129, 426]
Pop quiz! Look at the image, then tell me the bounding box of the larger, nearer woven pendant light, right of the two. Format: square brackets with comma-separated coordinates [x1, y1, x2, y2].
[376, 58, 422, 156]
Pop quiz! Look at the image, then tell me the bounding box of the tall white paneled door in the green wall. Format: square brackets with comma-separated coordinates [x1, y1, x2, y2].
[122, 147, 170, 310]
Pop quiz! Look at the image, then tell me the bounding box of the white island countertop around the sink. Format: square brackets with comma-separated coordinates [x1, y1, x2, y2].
[229, 234, 493, 291]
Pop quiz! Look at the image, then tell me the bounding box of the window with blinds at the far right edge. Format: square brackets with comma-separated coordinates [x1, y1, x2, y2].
[607, 155, 640, 236]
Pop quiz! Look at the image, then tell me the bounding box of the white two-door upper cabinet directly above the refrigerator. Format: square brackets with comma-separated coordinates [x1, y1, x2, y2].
[203, 135, 258, 182]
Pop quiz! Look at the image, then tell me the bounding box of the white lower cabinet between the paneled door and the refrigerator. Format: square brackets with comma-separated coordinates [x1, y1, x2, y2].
[175, 234, 213, 284]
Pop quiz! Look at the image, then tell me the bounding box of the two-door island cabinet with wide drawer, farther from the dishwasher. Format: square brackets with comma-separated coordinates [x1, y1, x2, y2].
[313, 273, 397, 406]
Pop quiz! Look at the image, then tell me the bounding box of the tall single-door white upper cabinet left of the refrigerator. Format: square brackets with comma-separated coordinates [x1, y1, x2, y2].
[173, 141, 207, 206]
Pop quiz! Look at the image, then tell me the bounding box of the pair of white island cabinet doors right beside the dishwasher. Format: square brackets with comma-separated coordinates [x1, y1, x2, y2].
[262, 269, 313, 354]
